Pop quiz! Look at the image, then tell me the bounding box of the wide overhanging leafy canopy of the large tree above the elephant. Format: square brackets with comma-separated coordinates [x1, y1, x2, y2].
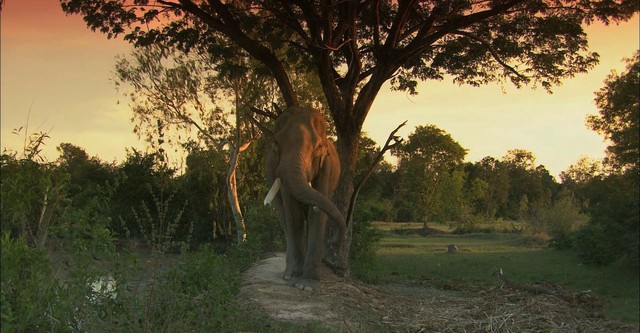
[61, 0, 637, 100]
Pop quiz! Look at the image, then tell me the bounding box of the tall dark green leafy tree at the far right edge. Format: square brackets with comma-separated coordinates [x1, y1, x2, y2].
[569, 52, 640, 268]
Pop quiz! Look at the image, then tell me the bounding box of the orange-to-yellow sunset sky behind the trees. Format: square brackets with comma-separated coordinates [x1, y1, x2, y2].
[0, 0, 639, 176]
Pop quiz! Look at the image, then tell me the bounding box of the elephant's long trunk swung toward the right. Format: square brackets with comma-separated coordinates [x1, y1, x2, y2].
[279, 161, 346, 231]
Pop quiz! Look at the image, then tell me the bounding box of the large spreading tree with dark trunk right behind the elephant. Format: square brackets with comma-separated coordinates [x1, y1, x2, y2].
[61, 0, 638, 268]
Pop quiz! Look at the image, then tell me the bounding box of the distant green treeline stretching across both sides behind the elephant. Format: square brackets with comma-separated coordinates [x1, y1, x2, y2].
[1, 126, 639, 264]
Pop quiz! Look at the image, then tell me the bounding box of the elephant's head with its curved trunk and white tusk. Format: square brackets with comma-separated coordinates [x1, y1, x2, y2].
[265, 108, 345, 227]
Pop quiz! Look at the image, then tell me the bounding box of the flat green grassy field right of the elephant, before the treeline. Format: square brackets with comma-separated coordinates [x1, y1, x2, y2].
[368, 224, 639, 324]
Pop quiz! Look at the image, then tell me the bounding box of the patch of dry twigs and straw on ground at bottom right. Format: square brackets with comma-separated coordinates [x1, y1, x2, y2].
[318, 272, 638, 333]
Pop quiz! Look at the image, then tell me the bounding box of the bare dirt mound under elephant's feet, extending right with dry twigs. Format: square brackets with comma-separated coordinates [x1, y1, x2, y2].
[240, 254, 638, 332]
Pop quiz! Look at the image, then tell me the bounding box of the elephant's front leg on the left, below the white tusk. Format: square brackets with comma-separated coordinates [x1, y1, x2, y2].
[275, 190, 306, 280]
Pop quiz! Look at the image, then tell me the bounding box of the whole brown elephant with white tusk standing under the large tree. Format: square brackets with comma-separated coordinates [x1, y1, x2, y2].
[264, 107, 346, 290]
